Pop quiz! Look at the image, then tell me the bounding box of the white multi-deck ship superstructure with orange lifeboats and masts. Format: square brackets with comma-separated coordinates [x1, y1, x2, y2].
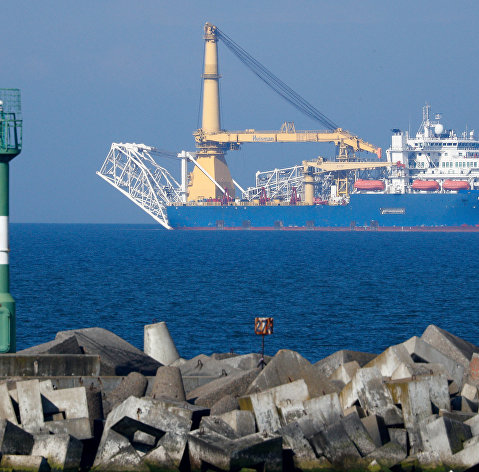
[386, 105, 479, 193]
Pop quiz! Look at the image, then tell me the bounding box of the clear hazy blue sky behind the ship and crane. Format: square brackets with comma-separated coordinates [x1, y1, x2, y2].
[0, 0, 479, 223]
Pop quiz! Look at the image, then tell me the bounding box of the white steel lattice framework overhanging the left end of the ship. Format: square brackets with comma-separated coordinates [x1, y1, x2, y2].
[97, 143, 186, 229]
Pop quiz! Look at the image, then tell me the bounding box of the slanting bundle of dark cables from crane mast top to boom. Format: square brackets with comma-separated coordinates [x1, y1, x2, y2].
[216, 28, 339, 131]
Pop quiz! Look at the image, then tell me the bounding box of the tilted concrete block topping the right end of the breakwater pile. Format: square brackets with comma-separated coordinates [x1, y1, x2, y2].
[421, 325, 479, 372]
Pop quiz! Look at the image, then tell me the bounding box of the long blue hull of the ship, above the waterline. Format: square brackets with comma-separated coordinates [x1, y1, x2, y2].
[167, 190, 479, 231]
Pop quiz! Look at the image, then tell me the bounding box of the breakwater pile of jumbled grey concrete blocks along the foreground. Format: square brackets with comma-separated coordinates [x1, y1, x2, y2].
[0, 323, 479, 472]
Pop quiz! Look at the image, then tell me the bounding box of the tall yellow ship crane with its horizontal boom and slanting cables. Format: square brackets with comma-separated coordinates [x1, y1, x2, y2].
[188, 23, 381, 201]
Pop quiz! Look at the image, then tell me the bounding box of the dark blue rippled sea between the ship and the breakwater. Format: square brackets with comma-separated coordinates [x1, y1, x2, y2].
[7, 224, 479, 361]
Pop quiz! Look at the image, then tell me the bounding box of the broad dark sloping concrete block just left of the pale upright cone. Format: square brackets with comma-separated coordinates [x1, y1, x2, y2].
[55, 328, 161, 375]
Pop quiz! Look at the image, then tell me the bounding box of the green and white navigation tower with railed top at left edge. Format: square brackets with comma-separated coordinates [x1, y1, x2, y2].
[0, 89, 22, 353]
